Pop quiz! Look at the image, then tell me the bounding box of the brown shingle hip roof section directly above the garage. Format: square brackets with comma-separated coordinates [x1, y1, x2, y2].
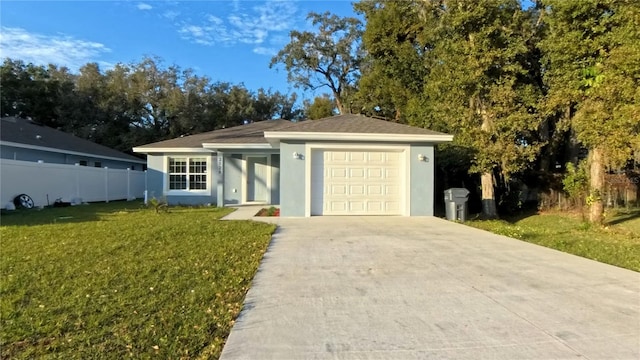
[279, 114, 446, 135]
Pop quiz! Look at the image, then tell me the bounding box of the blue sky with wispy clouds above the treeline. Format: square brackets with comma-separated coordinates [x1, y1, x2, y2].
[0, 0, 355, 101]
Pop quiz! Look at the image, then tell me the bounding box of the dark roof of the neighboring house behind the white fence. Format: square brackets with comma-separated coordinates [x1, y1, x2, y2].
[0, 117, 146, 164]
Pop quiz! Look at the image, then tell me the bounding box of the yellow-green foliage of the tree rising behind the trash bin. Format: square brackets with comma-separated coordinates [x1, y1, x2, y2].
[422, 0, 541, 180]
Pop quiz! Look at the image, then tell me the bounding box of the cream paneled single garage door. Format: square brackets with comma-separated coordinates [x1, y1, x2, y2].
[311, 150, 403, 215]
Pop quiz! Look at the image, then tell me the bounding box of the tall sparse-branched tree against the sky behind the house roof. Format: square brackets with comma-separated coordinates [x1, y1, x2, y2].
[270, 12, 362, 114]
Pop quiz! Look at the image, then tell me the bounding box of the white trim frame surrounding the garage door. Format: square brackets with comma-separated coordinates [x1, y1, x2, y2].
[304, 143, 411, 217]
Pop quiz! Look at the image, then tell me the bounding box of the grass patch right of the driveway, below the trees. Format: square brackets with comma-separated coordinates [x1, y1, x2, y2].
[467, 209, 640, 271]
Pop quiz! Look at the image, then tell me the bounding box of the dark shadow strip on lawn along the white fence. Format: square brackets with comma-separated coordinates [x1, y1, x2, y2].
[0, 200, 143, 226]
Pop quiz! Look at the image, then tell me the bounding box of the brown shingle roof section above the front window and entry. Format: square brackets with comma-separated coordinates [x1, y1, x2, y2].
[137, 120, 293, 149]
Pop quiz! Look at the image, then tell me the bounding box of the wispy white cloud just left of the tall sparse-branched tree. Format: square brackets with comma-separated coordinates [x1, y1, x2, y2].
[178, 0, 297, 55]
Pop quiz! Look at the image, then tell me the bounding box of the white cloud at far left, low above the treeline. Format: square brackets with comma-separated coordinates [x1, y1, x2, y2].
[0, 26, 111, 71]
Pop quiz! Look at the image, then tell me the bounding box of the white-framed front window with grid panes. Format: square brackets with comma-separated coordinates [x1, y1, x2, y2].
[169, 158, 207, 190]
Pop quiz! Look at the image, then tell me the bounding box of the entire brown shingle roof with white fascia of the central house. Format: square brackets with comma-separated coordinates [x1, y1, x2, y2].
[133, 114, 453, 153]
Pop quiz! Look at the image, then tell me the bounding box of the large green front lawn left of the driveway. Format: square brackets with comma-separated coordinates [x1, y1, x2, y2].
[0, 202, 274, 359]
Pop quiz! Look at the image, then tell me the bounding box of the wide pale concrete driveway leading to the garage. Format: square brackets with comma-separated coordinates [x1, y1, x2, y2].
[222, 217, 640, 360]
